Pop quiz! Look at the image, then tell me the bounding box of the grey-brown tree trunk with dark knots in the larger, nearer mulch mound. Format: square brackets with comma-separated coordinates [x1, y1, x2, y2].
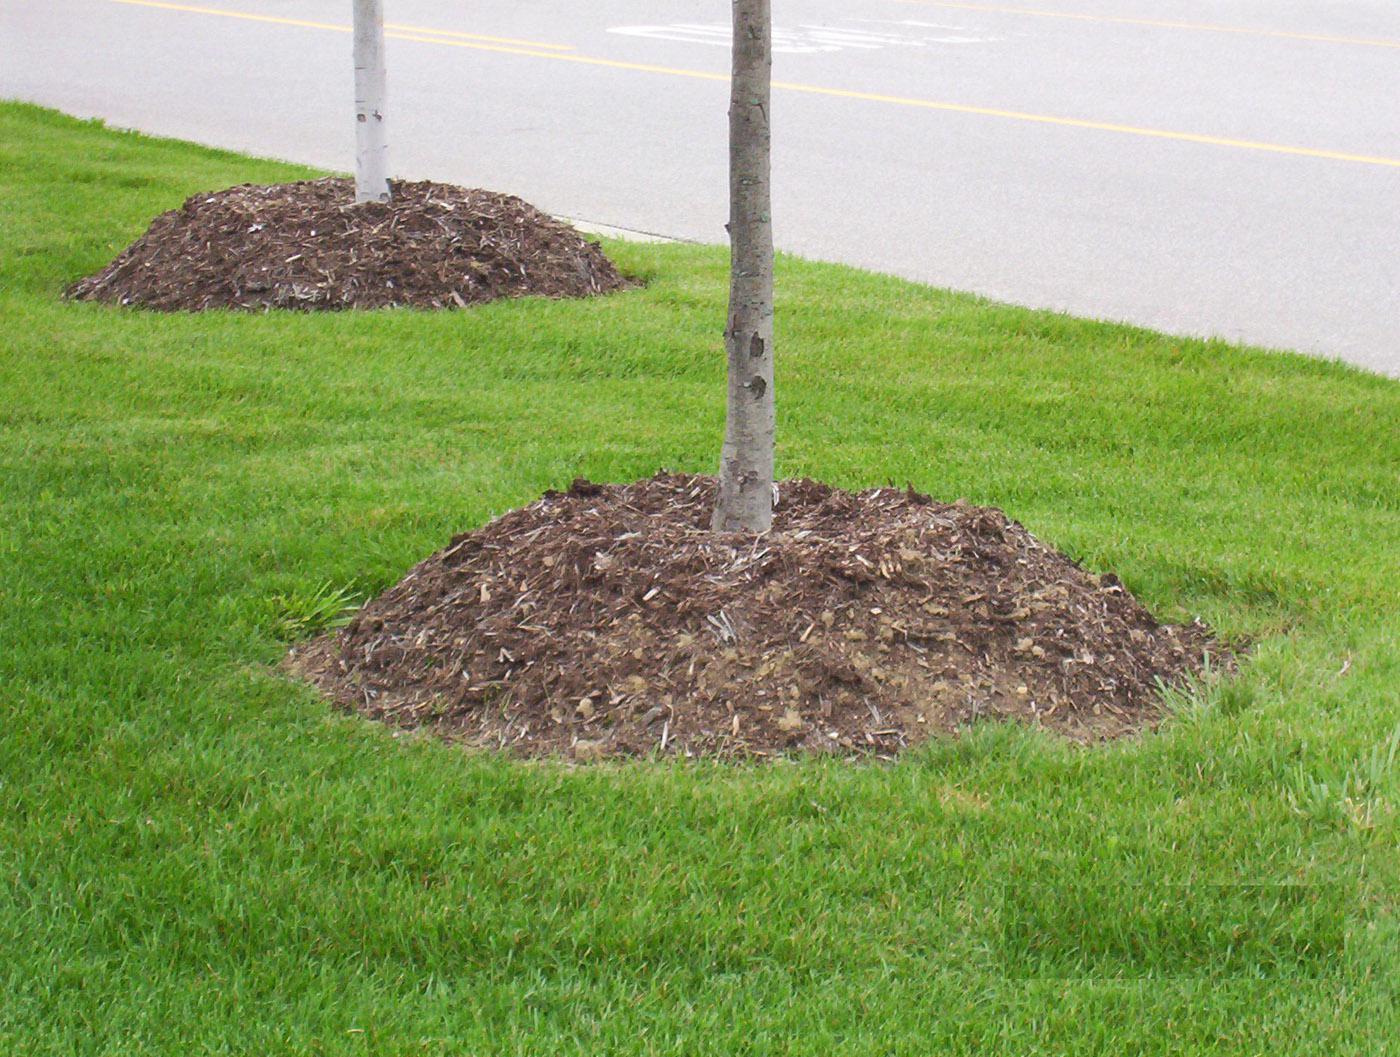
[710, 0, 774, 532]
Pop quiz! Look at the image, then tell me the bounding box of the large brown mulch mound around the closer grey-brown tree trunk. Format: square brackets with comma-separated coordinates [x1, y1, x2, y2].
[288, 473, 1229, 759]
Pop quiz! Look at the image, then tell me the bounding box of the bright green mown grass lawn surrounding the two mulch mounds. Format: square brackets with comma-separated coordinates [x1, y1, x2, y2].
[0, 97, 1400, 1057]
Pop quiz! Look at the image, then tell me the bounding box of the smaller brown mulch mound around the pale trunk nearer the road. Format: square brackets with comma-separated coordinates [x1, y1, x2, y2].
[67, 179, 629, 311]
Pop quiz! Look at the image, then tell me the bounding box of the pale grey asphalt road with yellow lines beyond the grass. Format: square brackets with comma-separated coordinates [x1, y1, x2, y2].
[8, 0, 1400, 375]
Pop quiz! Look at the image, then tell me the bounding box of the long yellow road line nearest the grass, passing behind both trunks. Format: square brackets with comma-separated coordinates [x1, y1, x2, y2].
[103, 0, 1400, 169]
